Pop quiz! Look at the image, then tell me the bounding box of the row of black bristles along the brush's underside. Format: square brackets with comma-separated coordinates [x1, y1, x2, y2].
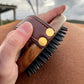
[26, 27, 67, 76]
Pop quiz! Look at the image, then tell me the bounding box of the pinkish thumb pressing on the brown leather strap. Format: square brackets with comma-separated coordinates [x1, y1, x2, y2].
[0, 22, 33, 63]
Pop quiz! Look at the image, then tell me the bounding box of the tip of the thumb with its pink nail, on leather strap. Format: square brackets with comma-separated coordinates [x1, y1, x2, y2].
[17, 22, 33, 34]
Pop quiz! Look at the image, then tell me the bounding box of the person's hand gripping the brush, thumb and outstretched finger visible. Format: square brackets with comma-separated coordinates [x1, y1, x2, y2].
[0, 5, 65, 84]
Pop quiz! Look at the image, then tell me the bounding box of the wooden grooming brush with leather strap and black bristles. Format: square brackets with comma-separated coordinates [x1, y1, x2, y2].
[16, 15, 67, 76]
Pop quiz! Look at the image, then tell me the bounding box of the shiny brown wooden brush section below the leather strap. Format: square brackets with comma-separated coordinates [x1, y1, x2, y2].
[17, 44, 42, 74]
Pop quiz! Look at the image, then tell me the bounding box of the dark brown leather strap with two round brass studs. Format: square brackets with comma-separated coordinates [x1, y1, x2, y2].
[16, 16, 55, 48]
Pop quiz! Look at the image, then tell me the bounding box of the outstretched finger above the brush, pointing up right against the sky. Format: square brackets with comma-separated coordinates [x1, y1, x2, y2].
[38, 5, 66, 22]
